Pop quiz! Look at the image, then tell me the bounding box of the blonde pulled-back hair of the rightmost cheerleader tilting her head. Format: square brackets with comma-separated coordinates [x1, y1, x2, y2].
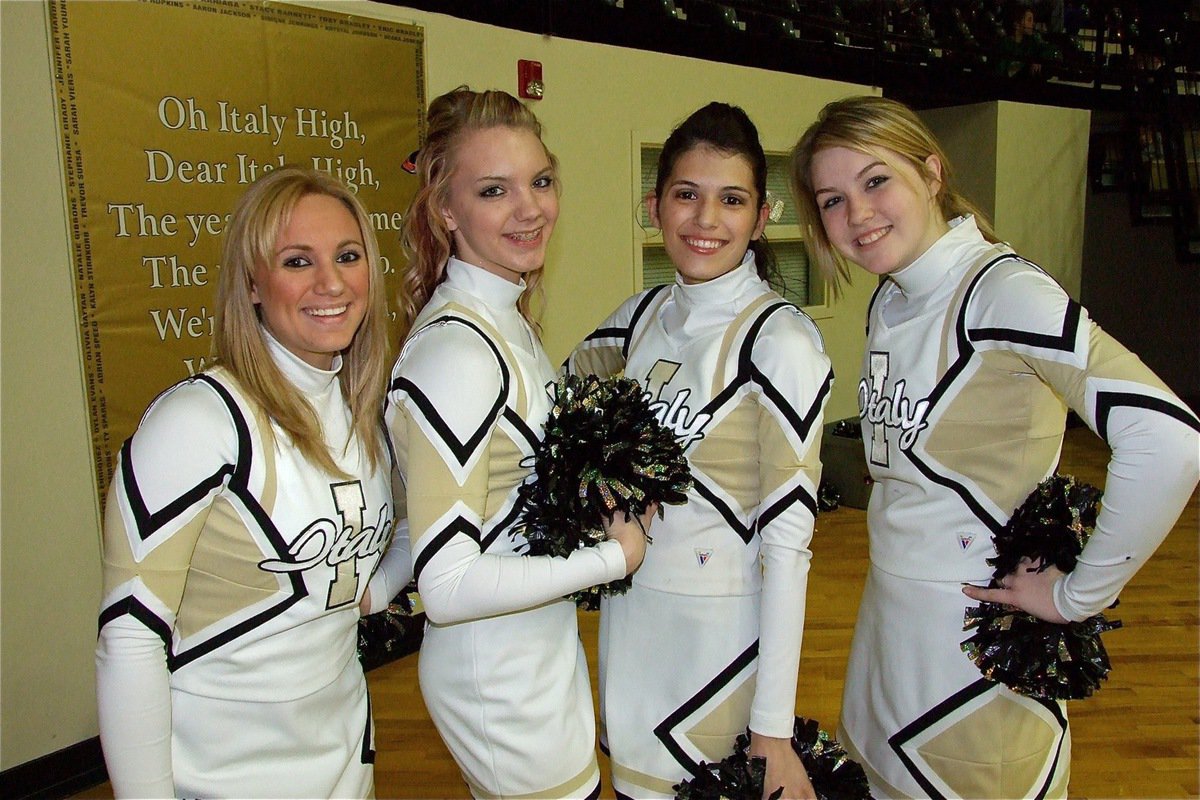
[788, 96, 998, 296]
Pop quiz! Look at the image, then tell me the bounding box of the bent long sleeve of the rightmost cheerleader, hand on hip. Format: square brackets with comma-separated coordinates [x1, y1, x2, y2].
[971, 260, 1200, 620]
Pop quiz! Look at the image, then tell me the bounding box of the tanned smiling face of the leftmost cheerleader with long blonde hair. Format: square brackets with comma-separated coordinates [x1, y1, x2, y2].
[251, 194, 371, 369]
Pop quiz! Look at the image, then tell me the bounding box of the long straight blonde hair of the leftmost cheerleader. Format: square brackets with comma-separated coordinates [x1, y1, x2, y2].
[214, 166, 390, 477]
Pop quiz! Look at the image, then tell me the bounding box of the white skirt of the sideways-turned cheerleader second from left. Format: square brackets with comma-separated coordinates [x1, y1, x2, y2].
[418, 600, 600, 798]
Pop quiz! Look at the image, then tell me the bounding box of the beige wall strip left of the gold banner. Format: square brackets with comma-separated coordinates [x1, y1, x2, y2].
[0, 2, 100, 769]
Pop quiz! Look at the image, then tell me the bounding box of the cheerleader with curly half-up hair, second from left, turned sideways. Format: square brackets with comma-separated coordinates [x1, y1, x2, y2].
[385, 89, 652, 798]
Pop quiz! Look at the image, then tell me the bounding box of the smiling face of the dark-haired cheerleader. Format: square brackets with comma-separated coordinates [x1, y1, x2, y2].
[646, 145, 768, 283]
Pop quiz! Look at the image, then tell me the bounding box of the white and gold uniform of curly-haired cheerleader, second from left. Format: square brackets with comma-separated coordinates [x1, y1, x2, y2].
[385, 258, 625, 798]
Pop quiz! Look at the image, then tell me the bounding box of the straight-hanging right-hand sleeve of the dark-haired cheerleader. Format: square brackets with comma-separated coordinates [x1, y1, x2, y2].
[750, 308, 833, 738]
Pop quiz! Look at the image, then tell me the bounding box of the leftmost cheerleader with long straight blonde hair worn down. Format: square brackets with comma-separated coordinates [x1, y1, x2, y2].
[96, 167, 409, 798]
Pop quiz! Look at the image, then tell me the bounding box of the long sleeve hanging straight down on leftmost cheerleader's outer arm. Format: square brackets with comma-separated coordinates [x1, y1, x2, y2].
[96, 384, 233, 798]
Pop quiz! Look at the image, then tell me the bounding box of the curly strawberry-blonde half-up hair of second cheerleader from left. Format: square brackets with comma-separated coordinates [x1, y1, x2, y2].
[400, 86, 558, 341]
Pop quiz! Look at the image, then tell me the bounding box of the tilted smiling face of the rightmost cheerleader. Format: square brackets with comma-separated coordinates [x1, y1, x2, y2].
[810, 148, 949, 275]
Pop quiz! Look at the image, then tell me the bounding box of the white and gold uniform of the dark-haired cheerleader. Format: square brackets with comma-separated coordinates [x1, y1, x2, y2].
[568, 253, 833, 798]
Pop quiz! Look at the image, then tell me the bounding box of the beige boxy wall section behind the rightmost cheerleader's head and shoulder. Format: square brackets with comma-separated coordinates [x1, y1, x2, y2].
[920, 101, 1091, 300]
